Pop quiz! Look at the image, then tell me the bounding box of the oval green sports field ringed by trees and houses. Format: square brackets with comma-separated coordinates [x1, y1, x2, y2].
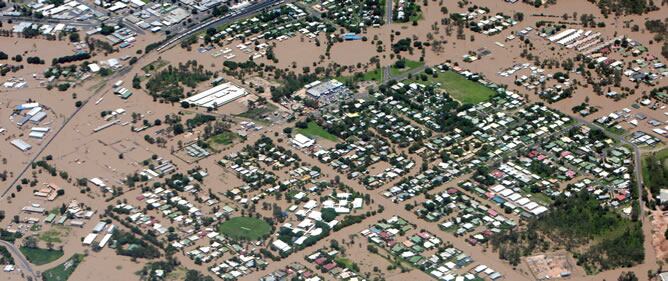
[218, 217, 271, 240]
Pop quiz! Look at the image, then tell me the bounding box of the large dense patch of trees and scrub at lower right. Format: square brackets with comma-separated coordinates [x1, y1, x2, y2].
[491, 192, 645, 273]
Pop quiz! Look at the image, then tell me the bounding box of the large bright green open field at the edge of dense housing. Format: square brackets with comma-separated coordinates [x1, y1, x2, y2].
[416, 71, 495, 104]
